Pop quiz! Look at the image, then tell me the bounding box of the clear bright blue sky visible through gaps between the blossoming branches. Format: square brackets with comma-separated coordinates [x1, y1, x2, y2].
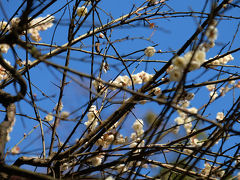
[0, 0, 240, 177]
